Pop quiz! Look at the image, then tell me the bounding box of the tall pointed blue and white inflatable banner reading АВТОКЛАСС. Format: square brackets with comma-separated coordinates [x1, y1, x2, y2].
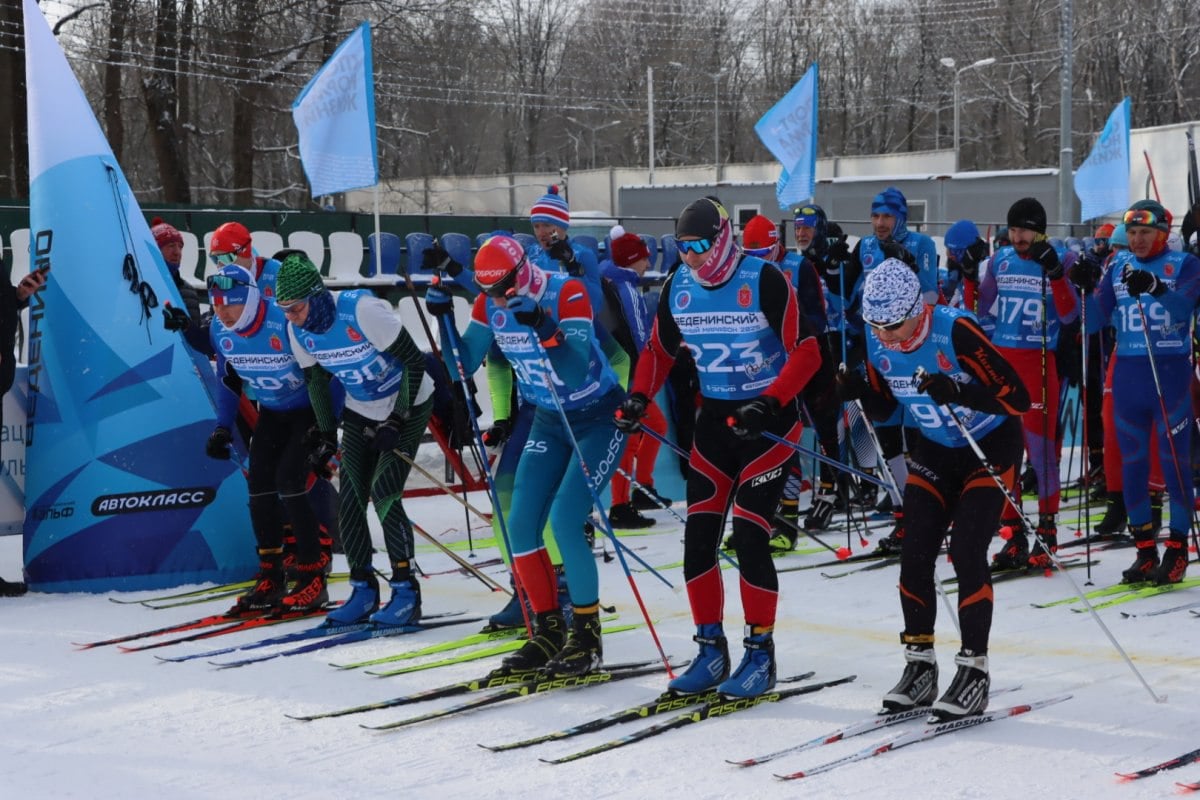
[17, 0, 257, 591]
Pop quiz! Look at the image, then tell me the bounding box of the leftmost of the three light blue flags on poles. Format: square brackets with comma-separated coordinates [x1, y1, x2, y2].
[292, 23, 379, 197]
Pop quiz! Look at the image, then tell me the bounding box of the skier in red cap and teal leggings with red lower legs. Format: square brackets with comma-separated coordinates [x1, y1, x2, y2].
[426, 236, 624, 674]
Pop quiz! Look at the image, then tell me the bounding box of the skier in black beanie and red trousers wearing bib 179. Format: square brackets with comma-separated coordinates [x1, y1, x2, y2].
[979, 197, 1079, 570]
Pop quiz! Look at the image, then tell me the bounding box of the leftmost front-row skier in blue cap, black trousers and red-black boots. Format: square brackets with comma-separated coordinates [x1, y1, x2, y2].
[204, 264, 333, 615]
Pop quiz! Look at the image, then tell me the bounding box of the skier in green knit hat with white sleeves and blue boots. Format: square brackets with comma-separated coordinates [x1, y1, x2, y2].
[275, 252, 433, 625]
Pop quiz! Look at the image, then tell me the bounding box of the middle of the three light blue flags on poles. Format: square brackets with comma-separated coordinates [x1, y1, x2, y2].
[754, 64, 817, 211]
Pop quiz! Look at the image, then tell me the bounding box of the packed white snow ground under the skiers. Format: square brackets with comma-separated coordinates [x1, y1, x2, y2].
[0, 448, 1200, 800]
